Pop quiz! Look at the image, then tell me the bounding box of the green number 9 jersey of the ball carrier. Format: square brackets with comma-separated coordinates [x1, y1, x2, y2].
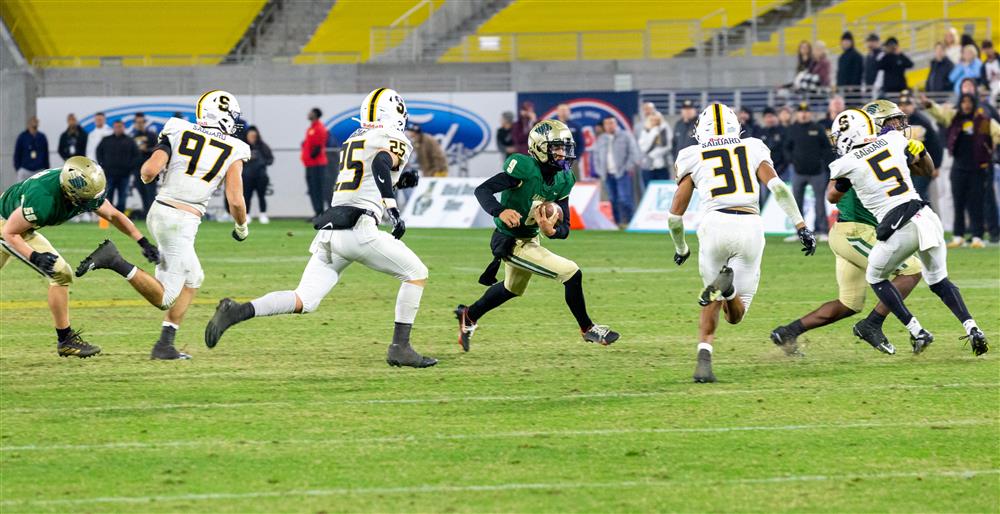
[493, 153, 576, 238]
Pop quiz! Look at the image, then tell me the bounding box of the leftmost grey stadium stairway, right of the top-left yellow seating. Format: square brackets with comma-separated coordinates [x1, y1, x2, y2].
[227, 0, 336, 62]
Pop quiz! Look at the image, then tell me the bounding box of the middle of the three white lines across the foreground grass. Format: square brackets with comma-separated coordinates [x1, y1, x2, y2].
[0, 419, 1000, 452]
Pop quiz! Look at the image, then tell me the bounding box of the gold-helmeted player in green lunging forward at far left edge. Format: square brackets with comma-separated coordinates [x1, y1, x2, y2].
[0, 156, 160, 358]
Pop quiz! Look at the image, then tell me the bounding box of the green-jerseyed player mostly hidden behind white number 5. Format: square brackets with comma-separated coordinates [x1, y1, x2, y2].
[771, 100, 934, 354]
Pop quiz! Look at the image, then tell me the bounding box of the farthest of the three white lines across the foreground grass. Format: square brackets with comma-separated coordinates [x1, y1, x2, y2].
[0, 383, 1000, 414]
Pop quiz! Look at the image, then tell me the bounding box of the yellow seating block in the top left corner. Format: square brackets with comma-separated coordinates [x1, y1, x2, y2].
[0, 0, 265, 66]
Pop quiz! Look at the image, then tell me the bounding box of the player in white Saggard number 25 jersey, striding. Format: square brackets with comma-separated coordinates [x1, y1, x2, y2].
[205, 87, 437, 368]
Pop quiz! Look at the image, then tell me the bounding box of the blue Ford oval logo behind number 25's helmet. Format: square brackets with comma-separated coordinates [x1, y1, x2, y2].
[326, 100, 492, 163]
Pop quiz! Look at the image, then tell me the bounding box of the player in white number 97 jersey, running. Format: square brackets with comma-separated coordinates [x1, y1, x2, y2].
[76, 90, 250, 360]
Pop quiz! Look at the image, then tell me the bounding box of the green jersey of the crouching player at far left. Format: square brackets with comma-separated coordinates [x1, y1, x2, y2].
[0, 168, 88, 228]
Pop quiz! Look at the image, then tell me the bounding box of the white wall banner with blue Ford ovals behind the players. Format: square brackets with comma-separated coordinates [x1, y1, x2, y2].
[37, 91, 516, 217]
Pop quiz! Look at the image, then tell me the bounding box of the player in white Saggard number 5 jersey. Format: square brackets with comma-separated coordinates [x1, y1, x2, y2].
[827, 109, 989, 355]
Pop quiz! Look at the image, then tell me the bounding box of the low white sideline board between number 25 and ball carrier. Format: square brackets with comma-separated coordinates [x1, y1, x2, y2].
[403, 177, 493, 228]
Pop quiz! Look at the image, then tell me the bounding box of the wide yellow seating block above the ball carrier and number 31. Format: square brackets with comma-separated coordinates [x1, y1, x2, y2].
[440, 0, 788, 62]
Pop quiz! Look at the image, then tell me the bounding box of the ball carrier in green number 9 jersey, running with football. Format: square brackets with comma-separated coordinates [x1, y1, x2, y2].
[455, 120, 619, 351]
